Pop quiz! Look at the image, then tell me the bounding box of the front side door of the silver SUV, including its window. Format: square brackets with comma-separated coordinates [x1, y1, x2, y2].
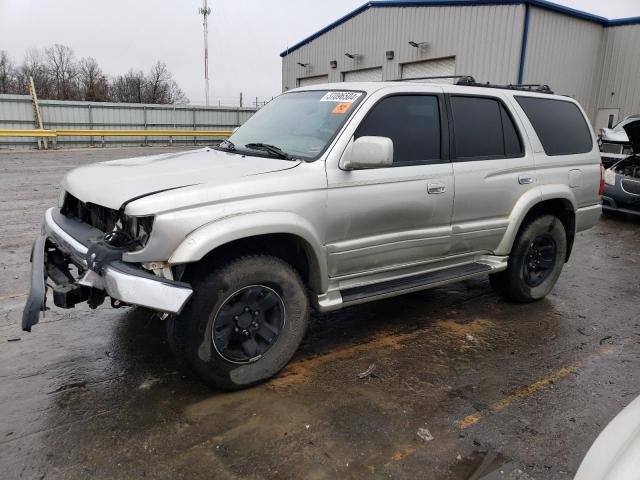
[327, 87, 454, 277]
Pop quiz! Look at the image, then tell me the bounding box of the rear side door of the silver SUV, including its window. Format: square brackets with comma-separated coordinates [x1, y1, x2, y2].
[445, 87, 535, 254]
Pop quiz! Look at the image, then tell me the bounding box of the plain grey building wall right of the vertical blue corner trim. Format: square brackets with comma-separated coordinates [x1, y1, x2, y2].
[524, 7, 606, 121]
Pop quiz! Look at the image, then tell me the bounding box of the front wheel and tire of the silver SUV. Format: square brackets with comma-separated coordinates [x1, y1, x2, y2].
[167, 255, 309, 390]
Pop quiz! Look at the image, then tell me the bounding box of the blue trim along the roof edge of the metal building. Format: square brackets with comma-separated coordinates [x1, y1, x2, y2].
[280, 0, 640, 60]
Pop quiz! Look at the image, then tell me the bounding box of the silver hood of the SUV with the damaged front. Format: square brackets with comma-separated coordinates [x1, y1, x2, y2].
[62, 148, 300, 210]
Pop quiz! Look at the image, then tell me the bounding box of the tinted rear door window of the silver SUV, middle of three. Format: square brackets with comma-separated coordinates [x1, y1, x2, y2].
[450, 96, 523, 161]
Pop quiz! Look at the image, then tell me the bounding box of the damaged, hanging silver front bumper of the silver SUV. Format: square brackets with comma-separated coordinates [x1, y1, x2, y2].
[22, 208, 193, 331]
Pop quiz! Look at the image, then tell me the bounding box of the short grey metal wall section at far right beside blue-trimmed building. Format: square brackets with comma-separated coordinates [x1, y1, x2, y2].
[598, 25, 640, 120]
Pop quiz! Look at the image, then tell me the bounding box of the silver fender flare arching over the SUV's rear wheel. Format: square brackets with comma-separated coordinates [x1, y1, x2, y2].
[494, 184, 578, 255]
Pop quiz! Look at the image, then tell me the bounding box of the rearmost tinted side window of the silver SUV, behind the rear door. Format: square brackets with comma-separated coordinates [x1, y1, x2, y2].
[515, 96, 593, 155]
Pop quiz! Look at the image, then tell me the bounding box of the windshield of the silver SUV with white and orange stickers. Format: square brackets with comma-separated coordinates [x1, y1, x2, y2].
[222, 90, 364, 160]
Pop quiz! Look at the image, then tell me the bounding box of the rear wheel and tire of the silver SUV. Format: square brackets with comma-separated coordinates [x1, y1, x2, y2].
[489, 215, 567, 303]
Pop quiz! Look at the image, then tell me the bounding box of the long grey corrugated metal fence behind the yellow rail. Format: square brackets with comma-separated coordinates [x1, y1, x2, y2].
[0, 95, 256, 148]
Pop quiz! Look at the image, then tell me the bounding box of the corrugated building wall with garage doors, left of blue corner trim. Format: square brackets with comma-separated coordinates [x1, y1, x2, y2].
[282, 5, 524, 90]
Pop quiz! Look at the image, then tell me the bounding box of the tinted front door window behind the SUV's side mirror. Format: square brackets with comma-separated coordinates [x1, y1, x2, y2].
[355, 95, 442, 166]
